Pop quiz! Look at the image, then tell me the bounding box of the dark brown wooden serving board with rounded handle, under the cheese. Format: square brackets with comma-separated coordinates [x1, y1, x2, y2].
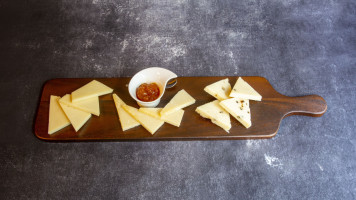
[35, 77, 327, 141]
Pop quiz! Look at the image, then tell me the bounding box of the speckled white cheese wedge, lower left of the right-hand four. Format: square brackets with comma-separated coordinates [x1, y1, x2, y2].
[195, 100, 231, 132]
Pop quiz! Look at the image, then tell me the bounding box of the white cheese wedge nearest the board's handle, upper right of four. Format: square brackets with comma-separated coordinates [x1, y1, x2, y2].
[230, 77, 262, 101]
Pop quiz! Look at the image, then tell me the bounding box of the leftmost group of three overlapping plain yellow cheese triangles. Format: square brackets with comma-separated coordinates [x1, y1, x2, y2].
[48, 80, 113, 134]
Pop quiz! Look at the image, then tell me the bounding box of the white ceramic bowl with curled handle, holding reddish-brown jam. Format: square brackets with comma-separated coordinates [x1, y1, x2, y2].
[129, 67, 178, 108]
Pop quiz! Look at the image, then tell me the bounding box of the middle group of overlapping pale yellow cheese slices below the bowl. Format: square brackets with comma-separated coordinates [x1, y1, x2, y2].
[113, 90, 195, 135]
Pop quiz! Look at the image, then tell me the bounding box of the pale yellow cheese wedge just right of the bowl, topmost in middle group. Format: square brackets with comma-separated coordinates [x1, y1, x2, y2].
[160, 90, 195, 116]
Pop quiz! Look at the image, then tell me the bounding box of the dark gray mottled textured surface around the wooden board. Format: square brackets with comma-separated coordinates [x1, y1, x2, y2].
[0, 0, 356, 200]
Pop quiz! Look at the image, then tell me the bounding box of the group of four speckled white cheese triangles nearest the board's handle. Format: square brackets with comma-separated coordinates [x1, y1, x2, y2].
[195, 77, 262, 132]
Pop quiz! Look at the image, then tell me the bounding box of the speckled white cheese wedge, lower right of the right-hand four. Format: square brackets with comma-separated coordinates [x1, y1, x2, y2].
[220, 98, 252, 128]
